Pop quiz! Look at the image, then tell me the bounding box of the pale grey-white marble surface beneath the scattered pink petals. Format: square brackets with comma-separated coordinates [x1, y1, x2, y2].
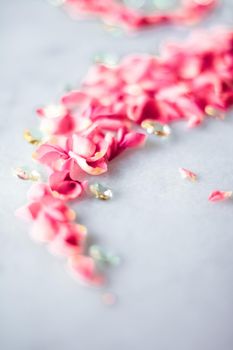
[0, 0, 233, 350]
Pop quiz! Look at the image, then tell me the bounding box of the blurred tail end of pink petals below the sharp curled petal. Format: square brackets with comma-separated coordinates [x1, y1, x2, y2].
[16, 184, 104, 286]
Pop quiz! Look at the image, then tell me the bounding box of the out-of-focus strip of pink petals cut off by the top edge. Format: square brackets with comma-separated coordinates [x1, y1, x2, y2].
[63, 0, 218, 30]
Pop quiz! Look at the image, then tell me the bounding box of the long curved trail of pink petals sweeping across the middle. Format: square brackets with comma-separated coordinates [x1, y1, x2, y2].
[18, 29, 233, 285]
